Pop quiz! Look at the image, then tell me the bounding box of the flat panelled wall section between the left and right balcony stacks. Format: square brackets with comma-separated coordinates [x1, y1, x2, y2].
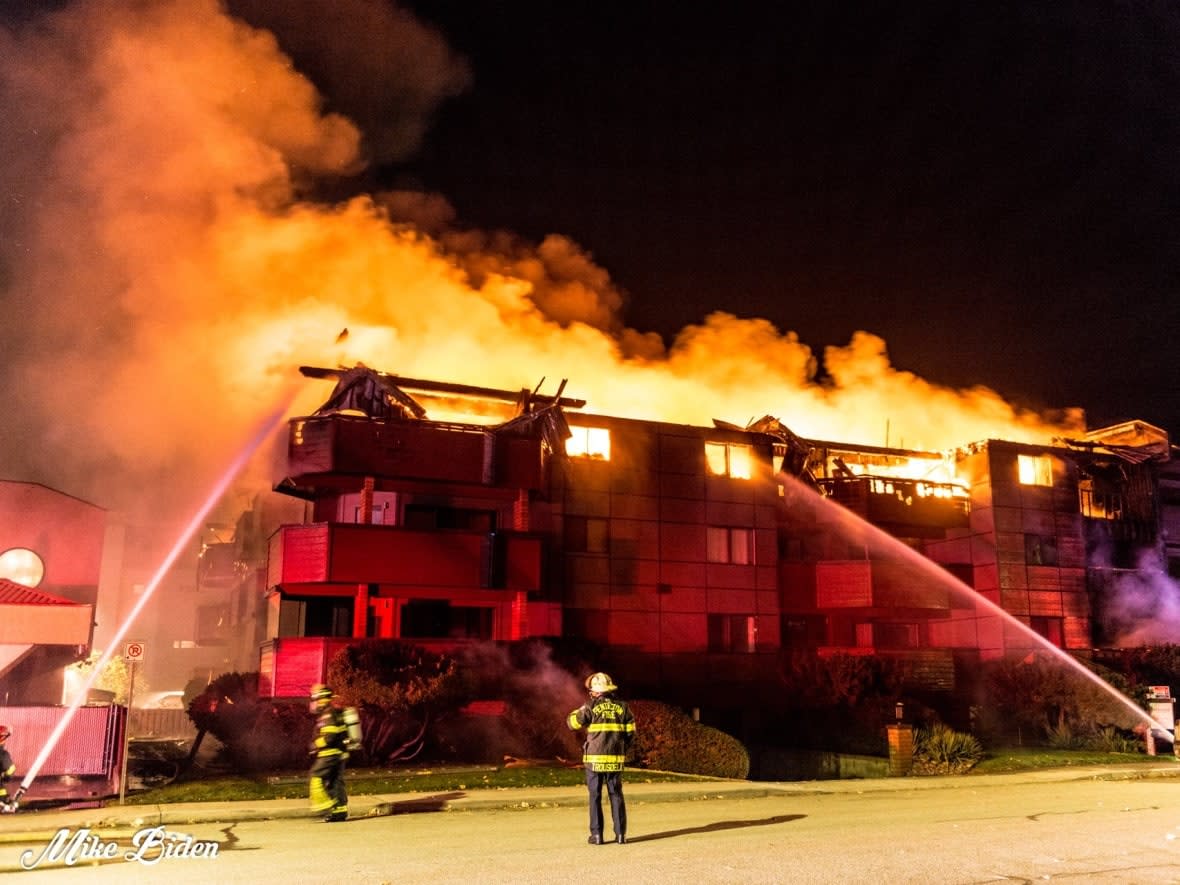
[533, 415, 780, 703]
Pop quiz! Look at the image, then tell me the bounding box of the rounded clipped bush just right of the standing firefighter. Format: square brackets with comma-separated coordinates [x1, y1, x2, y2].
[629, 701, 749, 778]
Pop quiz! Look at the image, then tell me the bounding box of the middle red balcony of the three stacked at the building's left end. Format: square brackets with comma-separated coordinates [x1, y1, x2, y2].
[267, 523, 542, 591]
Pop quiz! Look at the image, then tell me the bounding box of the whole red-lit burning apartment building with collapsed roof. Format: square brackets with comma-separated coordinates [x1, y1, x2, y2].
[244, 366, 1180, 731]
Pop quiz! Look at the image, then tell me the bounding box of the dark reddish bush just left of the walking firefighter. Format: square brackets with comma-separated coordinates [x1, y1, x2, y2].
[189, 673, 315, 773]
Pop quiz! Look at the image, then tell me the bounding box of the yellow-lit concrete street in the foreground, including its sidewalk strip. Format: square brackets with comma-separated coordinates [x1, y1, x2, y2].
[0, 760, 1180, 885]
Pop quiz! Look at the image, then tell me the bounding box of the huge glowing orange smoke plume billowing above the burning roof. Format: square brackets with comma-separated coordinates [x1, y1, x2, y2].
[0, 0, 1080, 526]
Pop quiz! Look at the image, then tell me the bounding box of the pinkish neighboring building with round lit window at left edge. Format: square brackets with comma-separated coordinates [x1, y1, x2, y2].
[0, 480, 106, 706]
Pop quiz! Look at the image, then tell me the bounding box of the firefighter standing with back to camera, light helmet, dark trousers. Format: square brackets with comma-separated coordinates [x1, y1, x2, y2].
[568, 673, 635, 845]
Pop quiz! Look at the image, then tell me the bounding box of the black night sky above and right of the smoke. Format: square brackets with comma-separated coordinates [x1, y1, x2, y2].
[379, 0, 1180, 435]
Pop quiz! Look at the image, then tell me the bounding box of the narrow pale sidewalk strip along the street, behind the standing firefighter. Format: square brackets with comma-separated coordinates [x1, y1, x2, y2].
[0, 760, 1180, 844]
